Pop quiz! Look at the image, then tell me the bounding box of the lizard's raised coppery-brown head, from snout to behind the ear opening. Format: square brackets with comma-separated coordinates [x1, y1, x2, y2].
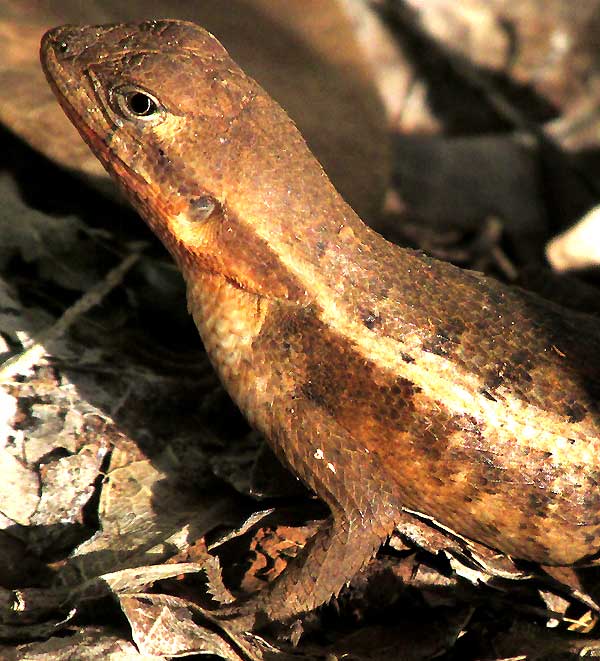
[41, 20, 348, 300]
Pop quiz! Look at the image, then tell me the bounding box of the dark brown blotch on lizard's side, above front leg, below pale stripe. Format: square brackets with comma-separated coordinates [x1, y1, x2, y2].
[277, 308, 517, 497]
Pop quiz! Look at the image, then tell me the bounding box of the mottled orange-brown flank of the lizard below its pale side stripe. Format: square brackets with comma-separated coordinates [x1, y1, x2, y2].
[253, 307, 600, 562]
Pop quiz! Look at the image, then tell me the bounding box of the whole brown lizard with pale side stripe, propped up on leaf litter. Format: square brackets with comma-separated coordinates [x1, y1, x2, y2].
[41, 20, 600, 626]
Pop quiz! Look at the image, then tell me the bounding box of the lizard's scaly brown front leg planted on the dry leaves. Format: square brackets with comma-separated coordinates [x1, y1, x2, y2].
[217, 400, 401, 631]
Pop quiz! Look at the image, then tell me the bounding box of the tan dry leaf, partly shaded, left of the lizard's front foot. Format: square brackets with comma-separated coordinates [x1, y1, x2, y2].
[60, 442, 232, 585]
